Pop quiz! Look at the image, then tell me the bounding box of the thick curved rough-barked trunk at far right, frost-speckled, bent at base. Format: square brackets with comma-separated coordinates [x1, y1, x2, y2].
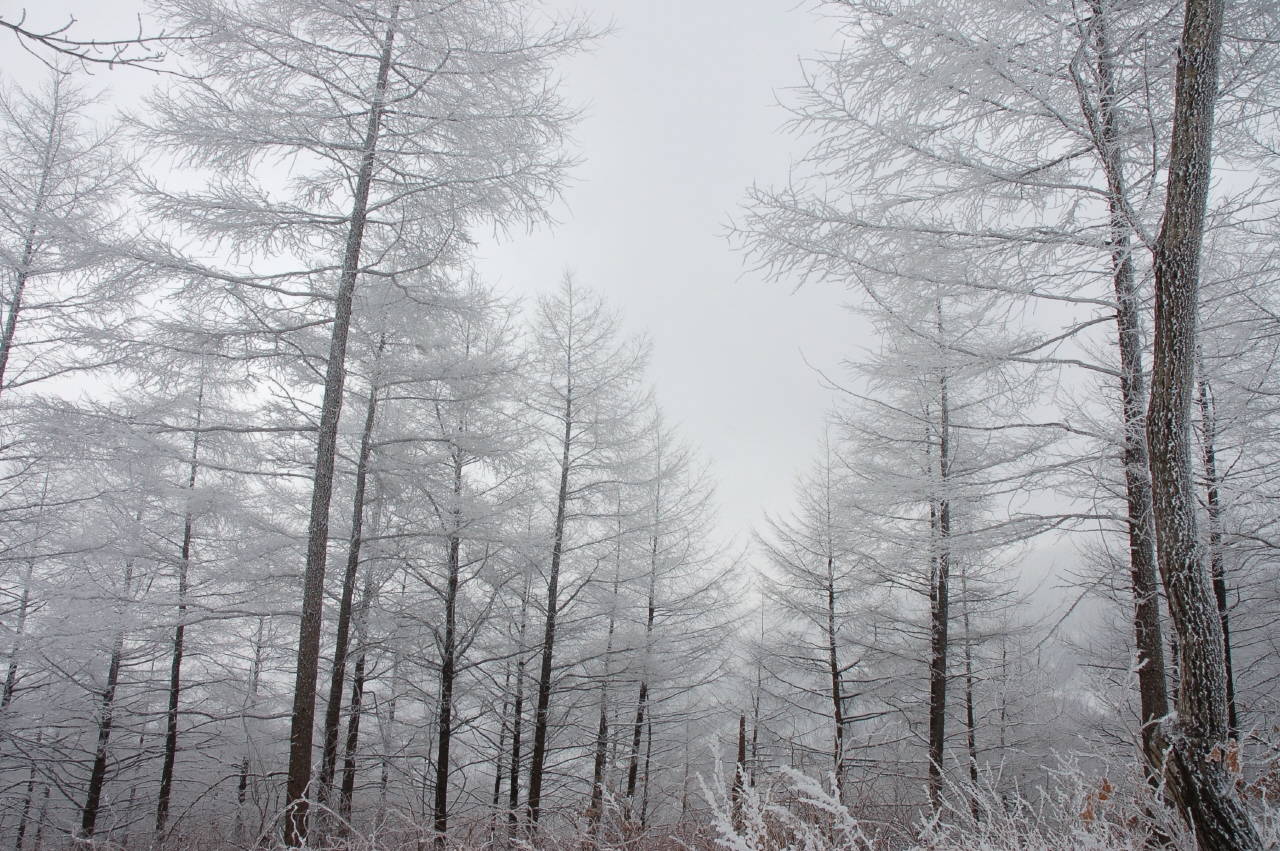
[1147, 0, 1262, 851]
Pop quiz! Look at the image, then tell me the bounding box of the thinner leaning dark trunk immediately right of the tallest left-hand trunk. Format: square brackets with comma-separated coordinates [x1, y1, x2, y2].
[317, 365, 387, 801]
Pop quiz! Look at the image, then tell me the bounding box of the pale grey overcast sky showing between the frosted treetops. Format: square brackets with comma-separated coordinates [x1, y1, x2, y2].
[0, 0, 867, 545]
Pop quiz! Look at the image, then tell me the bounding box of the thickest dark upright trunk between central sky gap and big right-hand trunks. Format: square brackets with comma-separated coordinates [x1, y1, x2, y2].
[929, 355, 951, 810]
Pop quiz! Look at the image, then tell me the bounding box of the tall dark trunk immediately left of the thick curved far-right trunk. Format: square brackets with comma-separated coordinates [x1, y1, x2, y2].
[1079, 0, 1169, 757]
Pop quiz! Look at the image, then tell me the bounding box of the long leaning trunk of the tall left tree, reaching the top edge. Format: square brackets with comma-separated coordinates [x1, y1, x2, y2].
[284, 3, 399, 847]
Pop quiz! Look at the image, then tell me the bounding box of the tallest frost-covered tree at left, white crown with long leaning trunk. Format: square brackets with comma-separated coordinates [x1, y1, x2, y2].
[132, 0, 585, 845]
